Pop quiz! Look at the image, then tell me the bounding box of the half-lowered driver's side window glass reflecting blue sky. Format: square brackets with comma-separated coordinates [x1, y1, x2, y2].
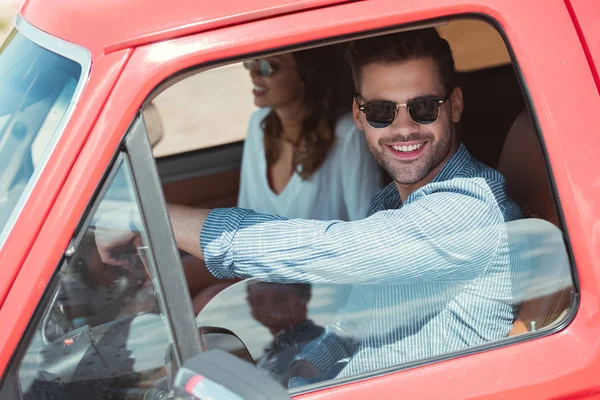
[196, 218, 573, 388]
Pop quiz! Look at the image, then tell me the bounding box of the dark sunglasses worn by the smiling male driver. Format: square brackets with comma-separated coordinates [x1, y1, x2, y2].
[354, 93, 450, 129]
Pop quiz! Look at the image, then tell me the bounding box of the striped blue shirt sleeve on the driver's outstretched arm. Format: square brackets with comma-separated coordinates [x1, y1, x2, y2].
[200, 178, 506, 284]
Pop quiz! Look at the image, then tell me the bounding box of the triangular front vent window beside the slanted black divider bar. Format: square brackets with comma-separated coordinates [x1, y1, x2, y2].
[18, 157, 172, 399]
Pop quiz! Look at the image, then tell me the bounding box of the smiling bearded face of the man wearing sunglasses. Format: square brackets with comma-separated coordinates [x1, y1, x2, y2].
[353, 58, 462, 185]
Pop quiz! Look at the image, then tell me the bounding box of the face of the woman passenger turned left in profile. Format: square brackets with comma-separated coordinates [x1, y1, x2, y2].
[250, 54, 304, 109]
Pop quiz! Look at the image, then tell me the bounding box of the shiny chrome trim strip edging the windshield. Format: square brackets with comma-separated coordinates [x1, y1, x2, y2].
[0, 15, 92, 251]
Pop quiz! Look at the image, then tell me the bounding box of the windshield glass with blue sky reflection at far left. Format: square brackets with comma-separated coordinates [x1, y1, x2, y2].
[0, 31, 82, 238]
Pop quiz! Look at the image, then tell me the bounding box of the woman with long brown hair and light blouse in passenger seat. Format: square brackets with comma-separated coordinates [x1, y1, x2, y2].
[238, 48, 383, 220]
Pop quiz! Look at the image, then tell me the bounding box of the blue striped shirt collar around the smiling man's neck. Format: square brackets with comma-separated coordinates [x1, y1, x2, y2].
[369, 143, 473, 215]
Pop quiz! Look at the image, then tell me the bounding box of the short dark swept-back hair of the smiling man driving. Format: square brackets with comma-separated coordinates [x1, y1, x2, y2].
[346, 28, 456, 93]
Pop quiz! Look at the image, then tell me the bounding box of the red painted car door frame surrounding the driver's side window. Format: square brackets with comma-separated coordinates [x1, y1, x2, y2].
[2, 0, 600, 399]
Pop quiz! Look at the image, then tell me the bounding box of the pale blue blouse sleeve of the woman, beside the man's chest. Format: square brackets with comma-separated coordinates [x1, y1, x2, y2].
[341, 120, 383, 221]
